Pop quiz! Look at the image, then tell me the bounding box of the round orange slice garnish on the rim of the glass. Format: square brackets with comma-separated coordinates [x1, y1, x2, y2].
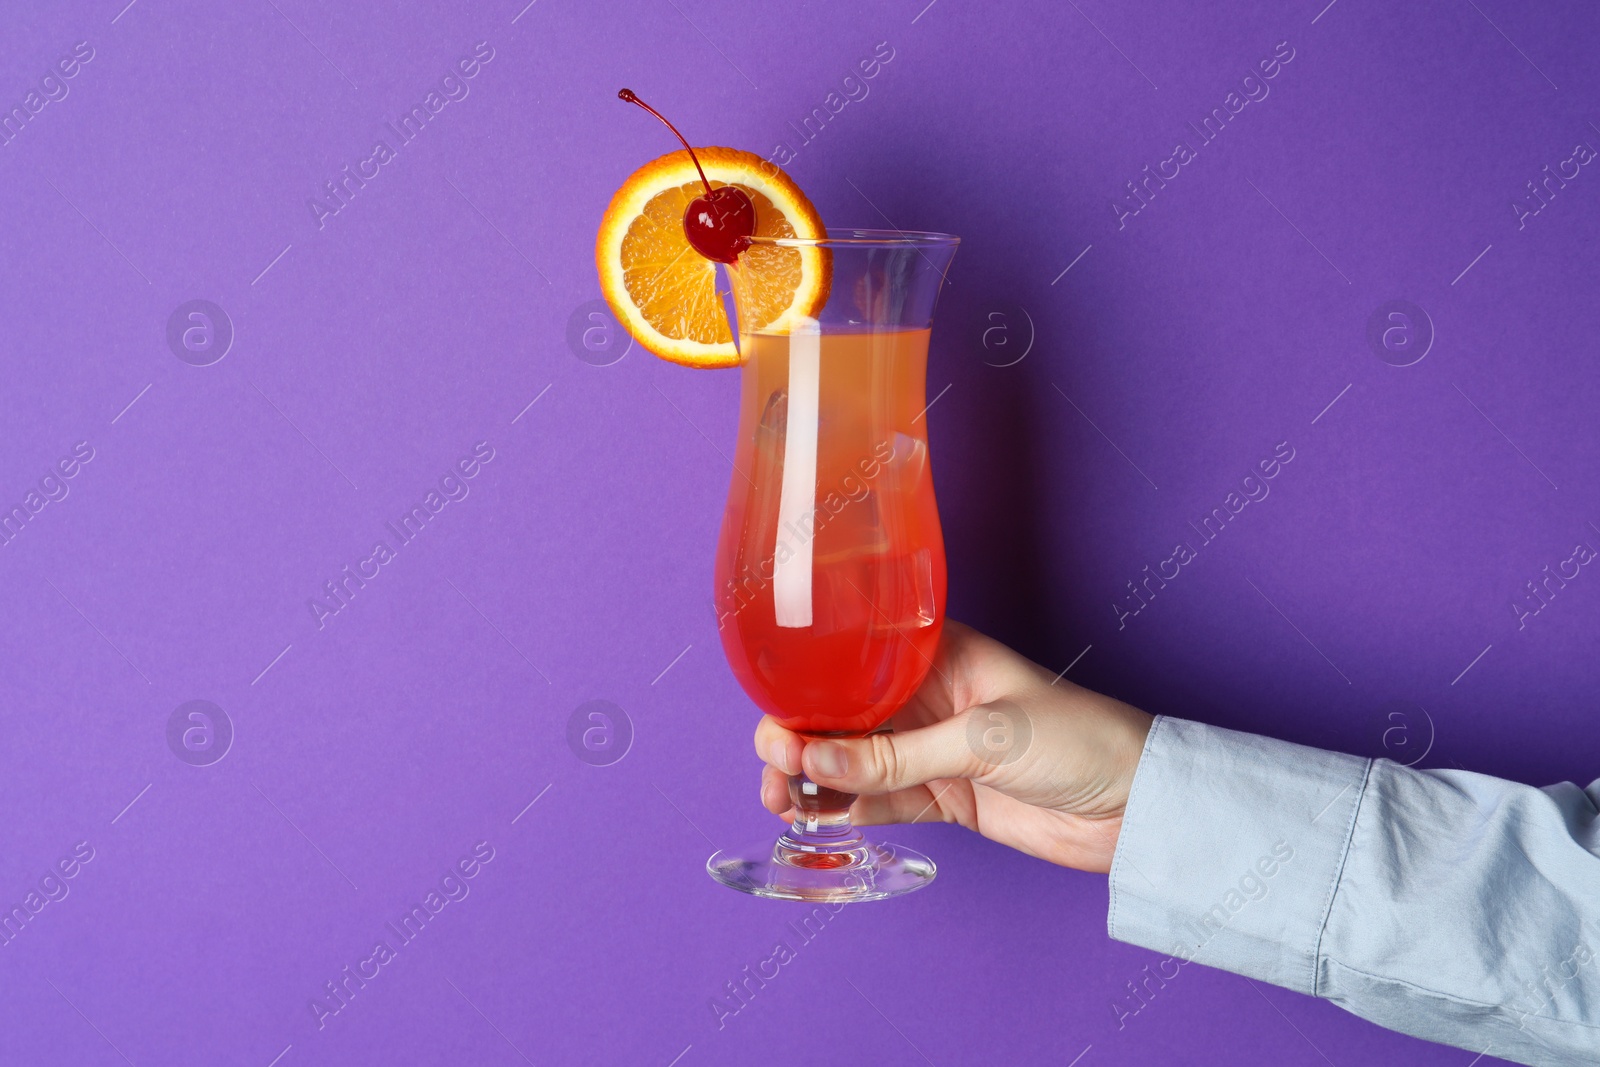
[595, 149, 829, 366]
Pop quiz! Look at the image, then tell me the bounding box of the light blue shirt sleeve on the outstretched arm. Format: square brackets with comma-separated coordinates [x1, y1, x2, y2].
[1107, 715, 1600, 1067]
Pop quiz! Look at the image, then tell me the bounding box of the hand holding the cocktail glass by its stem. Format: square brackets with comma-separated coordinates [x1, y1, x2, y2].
[755, 621, 1152, 873]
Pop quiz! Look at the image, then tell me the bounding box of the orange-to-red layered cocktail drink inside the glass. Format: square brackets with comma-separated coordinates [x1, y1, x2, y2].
[717, 330, 944, 734]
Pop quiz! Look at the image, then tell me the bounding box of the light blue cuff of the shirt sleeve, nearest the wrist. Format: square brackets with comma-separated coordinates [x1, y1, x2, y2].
[1106, 715, 1371, 995]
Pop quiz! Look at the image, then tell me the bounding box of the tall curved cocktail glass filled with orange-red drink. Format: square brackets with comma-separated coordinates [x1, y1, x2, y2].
[706, 230, 958, 901]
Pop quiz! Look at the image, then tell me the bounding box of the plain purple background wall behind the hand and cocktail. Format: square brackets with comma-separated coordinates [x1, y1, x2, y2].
[0, 0, 1600, 1067]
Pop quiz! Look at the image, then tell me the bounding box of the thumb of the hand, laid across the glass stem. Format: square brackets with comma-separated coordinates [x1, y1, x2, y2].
[800, 705, 994, 793]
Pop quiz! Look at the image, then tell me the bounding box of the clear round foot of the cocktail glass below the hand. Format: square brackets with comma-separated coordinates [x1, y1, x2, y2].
[706, 833, 938, 904]
